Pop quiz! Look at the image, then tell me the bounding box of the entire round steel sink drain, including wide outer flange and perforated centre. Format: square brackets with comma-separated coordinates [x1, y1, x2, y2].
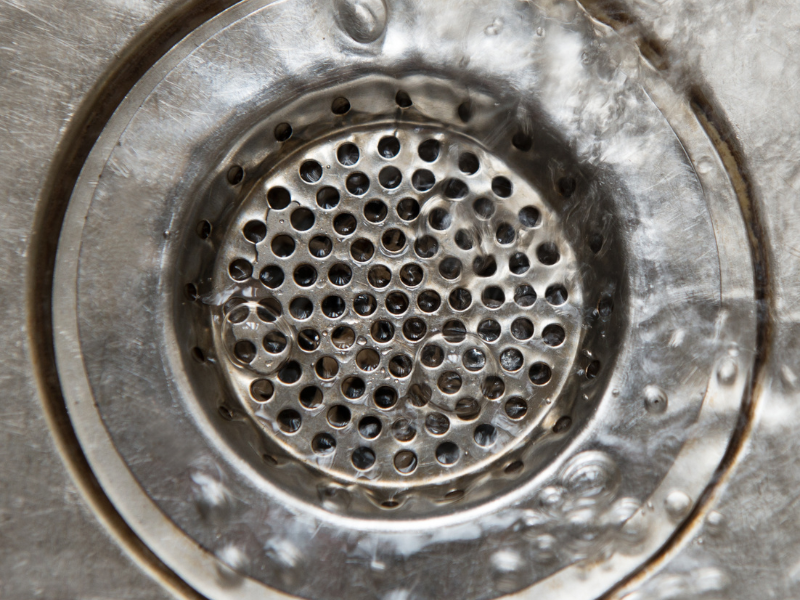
[54, 0, 755, 600]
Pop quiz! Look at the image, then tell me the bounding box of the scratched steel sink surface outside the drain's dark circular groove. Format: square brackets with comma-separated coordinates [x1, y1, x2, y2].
[0, 2, 800, 600]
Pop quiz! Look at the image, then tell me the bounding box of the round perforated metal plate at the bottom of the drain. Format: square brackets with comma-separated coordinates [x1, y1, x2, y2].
[209, 123, 582, 488]
